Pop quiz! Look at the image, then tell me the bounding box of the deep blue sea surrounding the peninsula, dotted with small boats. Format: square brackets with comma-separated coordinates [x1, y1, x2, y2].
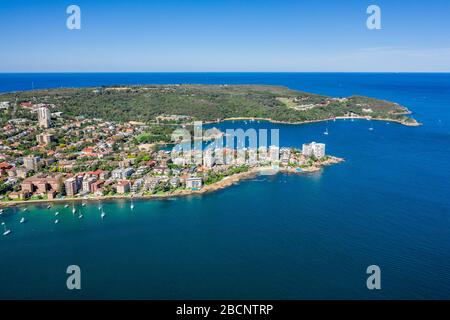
[0, 73, 450, 299]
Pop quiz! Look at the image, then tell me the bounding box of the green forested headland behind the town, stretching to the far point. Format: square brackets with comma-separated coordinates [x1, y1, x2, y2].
[0, 85, 414, 123]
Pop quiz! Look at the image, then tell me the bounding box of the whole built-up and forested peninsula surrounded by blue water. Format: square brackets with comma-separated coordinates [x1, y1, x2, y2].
[0, 85, 418, 205]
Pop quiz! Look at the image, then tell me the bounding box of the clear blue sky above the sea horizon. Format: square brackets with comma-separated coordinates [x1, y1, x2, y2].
[0, 0, 450, 72]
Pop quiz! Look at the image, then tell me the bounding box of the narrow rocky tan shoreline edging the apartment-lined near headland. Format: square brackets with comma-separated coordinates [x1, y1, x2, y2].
[0, 156, 345, 208]
